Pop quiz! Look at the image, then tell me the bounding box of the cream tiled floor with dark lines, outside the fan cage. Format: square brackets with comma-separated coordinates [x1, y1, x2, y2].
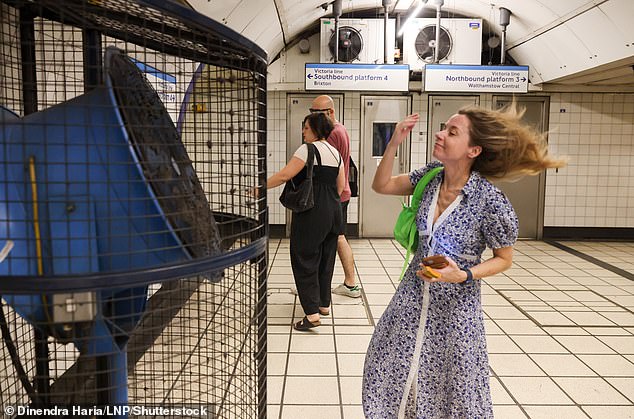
[268, 240, 634, 419]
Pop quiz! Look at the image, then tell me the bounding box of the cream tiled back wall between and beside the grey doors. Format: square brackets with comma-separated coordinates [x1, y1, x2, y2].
[268, 91, 634, 228]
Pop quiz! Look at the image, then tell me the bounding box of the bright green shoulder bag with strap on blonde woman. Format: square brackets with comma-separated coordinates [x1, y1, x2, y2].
[394, 166, 443, 279]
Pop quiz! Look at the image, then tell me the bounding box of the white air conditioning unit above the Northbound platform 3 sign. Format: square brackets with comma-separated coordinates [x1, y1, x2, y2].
[403, 18, 482, 71]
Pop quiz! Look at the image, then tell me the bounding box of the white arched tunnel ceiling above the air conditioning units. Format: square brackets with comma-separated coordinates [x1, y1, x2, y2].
[189, 0, 634, 88]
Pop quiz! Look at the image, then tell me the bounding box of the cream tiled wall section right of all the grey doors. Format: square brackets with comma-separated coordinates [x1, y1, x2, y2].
[544, 93, 634, 228]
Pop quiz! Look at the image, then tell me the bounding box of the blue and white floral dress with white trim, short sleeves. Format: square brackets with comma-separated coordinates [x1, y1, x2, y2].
[363, 162, 518, 419]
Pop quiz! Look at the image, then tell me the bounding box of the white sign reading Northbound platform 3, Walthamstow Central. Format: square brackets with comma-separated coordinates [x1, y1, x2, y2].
[425, 64, 528, 93]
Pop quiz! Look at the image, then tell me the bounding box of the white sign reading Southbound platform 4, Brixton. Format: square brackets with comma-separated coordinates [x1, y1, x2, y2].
[305, 64, 409, 92]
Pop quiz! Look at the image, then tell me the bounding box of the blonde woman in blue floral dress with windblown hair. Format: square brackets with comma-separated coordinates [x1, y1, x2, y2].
[363, 106, 564, 419]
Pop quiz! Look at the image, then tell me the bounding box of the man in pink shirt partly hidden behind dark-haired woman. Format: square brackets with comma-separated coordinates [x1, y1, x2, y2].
[310, 95, 361, 298]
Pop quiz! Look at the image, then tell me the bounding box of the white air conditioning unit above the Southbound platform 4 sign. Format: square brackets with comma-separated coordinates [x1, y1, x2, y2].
[320, 18, 396, 64]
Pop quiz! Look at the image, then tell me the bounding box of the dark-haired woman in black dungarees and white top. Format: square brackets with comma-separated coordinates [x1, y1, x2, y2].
[266, 113, 345, 330]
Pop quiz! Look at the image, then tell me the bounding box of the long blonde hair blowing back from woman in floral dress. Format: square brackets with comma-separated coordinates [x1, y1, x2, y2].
[458, 101, 566, 180]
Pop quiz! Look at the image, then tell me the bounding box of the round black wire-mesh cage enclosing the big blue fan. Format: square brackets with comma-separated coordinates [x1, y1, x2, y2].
[0, 0, 267, 418]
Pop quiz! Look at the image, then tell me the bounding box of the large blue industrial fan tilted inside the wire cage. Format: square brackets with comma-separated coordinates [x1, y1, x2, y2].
[0, 47, 221, 410]
